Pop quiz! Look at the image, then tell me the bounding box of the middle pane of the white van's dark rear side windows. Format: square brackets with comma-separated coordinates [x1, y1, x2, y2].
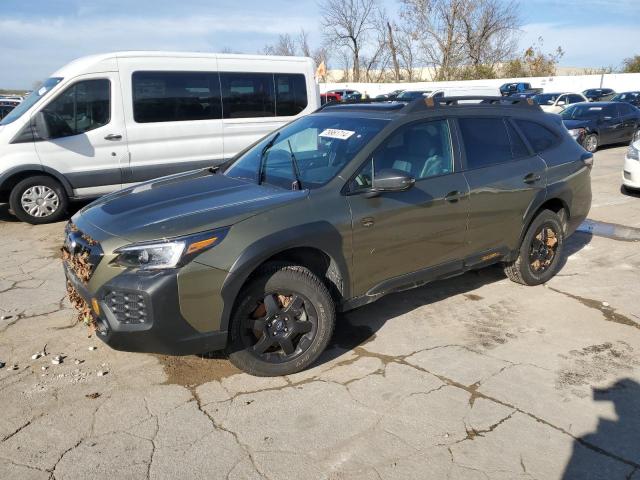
[220, 72, 276, 118]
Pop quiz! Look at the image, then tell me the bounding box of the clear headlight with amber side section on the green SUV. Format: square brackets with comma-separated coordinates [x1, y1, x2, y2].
[111, 228, 229, 270]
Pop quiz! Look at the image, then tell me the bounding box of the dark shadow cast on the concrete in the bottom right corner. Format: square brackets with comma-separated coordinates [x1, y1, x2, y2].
[562, 378, 640, 480]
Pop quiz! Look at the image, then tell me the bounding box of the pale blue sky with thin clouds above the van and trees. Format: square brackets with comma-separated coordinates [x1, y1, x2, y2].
[0, 0, 640, 88]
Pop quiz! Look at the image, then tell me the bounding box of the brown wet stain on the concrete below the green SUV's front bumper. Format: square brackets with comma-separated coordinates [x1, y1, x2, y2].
[156, 353, 242, 387]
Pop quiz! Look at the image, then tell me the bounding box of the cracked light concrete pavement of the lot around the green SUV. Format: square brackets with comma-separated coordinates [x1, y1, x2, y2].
[0, 147, 640, 480]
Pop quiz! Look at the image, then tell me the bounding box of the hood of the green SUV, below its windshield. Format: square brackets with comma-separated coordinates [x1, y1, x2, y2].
[72, 170, 307, 242]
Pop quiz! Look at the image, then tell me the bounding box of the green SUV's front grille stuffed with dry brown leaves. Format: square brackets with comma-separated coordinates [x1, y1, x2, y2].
[61, 223, 103, 284]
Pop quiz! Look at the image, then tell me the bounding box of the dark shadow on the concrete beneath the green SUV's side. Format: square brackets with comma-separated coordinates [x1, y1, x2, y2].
[314, 232, 592, 366]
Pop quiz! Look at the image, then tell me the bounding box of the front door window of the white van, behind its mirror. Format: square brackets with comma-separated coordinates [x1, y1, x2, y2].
[42, 80, 111, 139]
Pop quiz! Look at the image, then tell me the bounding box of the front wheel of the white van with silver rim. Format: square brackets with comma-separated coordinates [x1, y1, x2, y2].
[9, 175, 69, 225]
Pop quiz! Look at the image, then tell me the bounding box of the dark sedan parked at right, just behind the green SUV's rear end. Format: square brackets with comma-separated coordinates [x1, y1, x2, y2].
[560, 102, 640, 152]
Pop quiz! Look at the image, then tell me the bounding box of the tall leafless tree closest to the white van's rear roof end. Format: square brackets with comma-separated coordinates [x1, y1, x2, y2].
[319, 0, 378, 82]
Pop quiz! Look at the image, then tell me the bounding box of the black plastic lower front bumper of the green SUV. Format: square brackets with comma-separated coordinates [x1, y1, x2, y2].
[63, 262, 227, 355]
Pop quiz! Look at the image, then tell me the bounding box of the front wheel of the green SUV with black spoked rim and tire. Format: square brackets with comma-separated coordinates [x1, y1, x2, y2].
[227, 264, 335, 377]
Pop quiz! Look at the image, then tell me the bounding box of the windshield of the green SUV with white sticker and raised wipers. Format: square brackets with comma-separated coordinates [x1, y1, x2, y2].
[224, 115, 389, 189]
